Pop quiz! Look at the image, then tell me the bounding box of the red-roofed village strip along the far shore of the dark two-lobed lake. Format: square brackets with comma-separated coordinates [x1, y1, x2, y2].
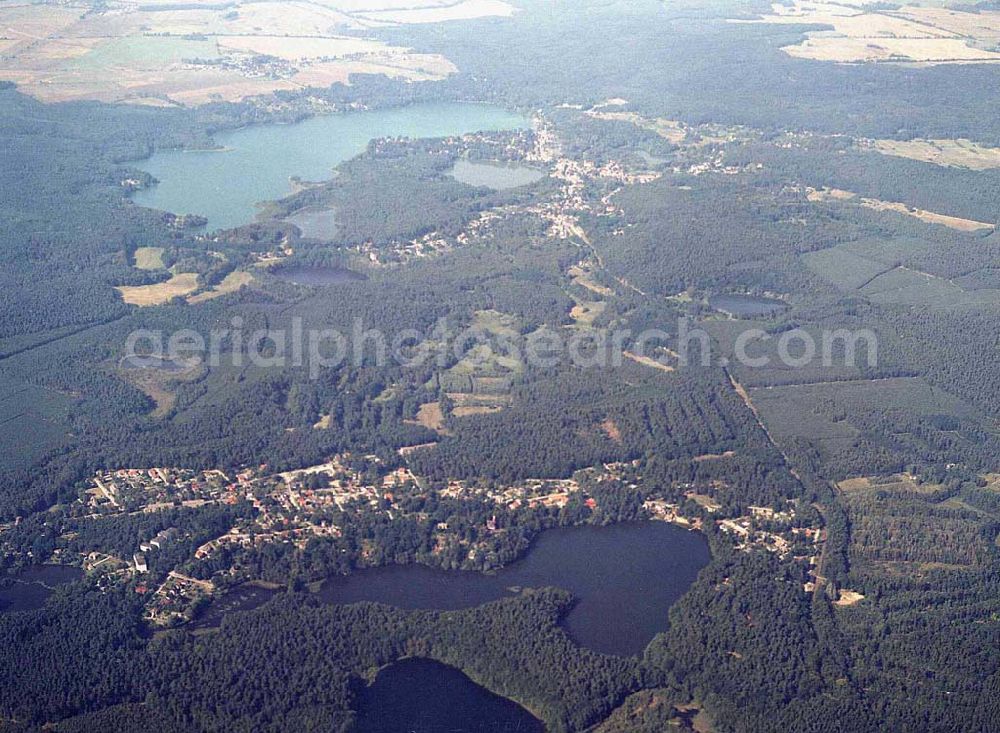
[31, 453, 825, 628]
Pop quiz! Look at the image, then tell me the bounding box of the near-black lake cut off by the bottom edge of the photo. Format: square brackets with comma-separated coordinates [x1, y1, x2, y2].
[356, 659, 545, 733]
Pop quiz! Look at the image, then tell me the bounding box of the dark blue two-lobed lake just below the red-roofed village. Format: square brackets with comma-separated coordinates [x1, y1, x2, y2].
[318, 522, 710, 656]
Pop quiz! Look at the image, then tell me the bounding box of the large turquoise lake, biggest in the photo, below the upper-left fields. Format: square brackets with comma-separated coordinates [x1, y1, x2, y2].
[132, 103, 529, 229]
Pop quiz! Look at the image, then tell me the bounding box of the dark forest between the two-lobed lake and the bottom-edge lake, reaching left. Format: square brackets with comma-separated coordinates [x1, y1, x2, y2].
[0, 586, 664, 732]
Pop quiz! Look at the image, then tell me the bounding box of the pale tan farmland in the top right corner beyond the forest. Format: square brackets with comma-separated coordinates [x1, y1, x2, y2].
[741, 0, 1000, 65]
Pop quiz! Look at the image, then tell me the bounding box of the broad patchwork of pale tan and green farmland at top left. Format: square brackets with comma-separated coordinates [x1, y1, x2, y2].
[0, 0, 514, 106]
